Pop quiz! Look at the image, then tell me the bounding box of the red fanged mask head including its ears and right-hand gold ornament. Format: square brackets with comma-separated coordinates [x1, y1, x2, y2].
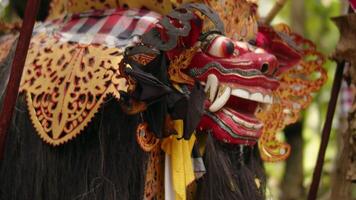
[130, 4, 326, 160]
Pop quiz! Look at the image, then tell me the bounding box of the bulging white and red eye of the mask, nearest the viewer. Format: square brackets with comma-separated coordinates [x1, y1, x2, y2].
[206, 36, 235, 58]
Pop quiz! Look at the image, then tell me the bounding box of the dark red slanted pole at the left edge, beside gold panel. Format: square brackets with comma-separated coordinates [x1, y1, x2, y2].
[0, 0, 41, 160]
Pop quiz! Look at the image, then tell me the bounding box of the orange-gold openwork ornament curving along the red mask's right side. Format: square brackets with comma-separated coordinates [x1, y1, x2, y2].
[259, 24, 327, 162]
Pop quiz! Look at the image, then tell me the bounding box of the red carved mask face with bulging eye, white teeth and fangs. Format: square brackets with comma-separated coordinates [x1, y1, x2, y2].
[187, 34, 279, 145]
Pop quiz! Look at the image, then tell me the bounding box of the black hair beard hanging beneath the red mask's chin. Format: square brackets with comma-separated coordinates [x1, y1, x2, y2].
[197, 134, 266, 200]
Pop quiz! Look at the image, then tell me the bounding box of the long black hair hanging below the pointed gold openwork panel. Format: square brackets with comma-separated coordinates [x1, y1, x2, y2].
[0, 95, 148, 200]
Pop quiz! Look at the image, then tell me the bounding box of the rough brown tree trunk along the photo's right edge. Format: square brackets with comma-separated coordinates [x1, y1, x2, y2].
[330, 10, 356, 200]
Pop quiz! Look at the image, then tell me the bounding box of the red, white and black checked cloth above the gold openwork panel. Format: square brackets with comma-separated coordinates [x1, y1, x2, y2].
[51, 8, 162, 47]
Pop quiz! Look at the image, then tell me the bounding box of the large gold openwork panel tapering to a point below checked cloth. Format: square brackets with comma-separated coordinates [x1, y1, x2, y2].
[20, 34, 129, 145]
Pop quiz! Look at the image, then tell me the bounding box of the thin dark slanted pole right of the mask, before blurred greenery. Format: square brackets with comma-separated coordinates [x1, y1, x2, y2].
[308, 61, 345, 200]
